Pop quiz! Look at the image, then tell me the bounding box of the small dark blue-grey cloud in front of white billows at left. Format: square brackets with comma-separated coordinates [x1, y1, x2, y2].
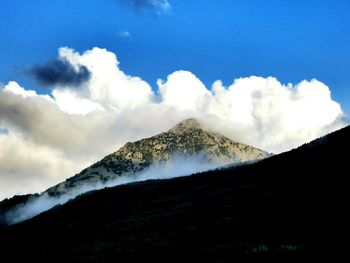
[29, 59, 91, 86]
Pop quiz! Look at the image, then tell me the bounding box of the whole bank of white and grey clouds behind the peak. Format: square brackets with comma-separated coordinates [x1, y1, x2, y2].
[0, 47, 345, 199]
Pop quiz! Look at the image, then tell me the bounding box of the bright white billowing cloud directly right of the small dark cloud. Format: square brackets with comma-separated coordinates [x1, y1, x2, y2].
[59, 48, 154, 110]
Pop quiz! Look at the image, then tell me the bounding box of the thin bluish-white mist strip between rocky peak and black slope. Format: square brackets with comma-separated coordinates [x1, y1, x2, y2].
[4, 154, 228, 225]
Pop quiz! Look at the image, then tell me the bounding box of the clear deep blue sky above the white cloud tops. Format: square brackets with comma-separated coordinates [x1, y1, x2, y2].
[0, 0, 350, 113]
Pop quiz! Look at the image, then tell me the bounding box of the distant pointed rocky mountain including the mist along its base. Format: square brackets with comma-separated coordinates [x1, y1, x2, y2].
[0, 118, 270, 224]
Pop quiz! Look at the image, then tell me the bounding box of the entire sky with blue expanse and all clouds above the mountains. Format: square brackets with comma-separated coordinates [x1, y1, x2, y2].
[0, 0, 350, 199]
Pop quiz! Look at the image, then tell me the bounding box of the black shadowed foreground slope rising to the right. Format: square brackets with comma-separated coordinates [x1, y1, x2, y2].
[0, 127, 350, 262]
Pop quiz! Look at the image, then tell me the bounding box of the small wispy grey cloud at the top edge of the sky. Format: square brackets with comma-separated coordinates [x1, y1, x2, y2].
[119, 0, 171, 14]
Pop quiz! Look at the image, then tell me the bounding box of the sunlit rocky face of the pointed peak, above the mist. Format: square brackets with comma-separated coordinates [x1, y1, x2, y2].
[47, 118, 269, 195]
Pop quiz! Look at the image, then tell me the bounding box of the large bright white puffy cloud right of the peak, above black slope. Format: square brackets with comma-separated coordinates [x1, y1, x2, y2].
[209, 76, 343, 153]
